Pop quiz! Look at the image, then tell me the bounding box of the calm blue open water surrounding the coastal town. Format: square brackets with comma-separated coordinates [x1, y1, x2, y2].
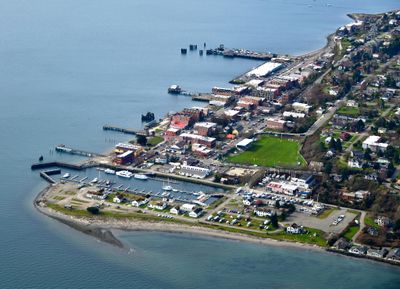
[0, 0, 400, 288]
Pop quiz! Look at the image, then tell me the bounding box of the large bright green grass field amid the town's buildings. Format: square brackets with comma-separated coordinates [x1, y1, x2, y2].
[228, 136, 306, 167]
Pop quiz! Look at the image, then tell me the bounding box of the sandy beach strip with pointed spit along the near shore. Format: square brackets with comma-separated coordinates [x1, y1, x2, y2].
[33, 185, 400, 267]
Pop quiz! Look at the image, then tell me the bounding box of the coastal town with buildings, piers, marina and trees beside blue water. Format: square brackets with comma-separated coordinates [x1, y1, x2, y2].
[32, 11, 400, 265]
